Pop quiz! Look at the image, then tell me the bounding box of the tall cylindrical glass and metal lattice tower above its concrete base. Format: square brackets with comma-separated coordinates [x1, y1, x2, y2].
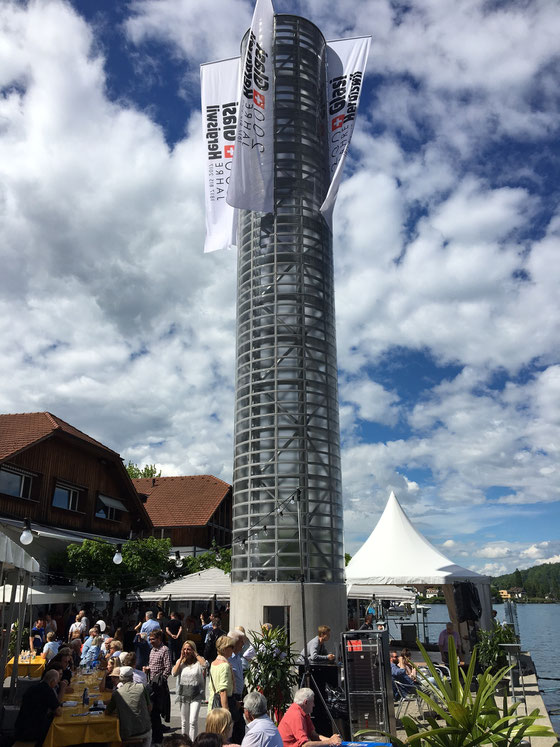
[232, 15, 344, 585]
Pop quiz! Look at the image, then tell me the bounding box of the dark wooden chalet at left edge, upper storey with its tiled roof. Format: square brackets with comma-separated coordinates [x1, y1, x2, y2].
[0, 412, 151, 544]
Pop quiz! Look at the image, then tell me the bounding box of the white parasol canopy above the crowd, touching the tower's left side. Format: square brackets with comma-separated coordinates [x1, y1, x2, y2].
[128, 568, 231, 602]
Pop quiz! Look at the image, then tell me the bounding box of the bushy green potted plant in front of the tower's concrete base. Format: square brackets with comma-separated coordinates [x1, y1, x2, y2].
[247, 626, 298, 723]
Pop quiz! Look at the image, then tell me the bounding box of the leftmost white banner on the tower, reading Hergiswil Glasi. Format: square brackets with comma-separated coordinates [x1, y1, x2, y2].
[200, 57, 239, 252]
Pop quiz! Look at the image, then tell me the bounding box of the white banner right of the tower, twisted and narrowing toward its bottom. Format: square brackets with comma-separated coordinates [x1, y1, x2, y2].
[321, 36, 371, 223]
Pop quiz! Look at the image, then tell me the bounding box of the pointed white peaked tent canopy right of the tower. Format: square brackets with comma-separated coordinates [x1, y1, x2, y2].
[346, 493, 489, 586]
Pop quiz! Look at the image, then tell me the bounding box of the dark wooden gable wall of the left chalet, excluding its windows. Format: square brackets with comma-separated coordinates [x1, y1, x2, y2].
[0, 432, 151, 539]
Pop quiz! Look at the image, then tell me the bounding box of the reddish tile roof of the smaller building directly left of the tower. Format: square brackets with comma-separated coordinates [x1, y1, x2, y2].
[132, 475, 231, 527]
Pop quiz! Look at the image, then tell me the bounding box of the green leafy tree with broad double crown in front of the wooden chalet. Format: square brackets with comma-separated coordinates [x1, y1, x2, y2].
[66, 537, 174, 609]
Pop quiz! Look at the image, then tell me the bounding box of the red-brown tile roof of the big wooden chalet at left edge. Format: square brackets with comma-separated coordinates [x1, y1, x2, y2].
[0, 412, 120, 461]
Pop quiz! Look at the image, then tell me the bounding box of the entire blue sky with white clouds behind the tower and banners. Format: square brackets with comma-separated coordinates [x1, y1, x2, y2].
[0, 0, 560, 574]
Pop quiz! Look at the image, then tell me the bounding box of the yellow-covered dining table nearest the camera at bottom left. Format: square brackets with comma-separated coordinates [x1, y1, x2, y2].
[43, 671, 122, 747]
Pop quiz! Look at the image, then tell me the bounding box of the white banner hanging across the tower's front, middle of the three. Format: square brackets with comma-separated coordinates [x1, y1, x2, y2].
[227, 0, 274, 213]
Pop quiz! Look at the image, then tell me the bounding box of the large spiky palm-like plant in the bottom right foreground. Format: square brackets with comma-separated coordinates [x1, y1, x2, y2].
[358, 638, 555, 747]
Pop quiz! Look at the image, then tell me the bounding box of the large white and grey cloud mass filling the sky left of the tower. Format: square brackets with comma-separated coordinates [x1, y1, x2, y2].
[0, 2, 235, 479]
